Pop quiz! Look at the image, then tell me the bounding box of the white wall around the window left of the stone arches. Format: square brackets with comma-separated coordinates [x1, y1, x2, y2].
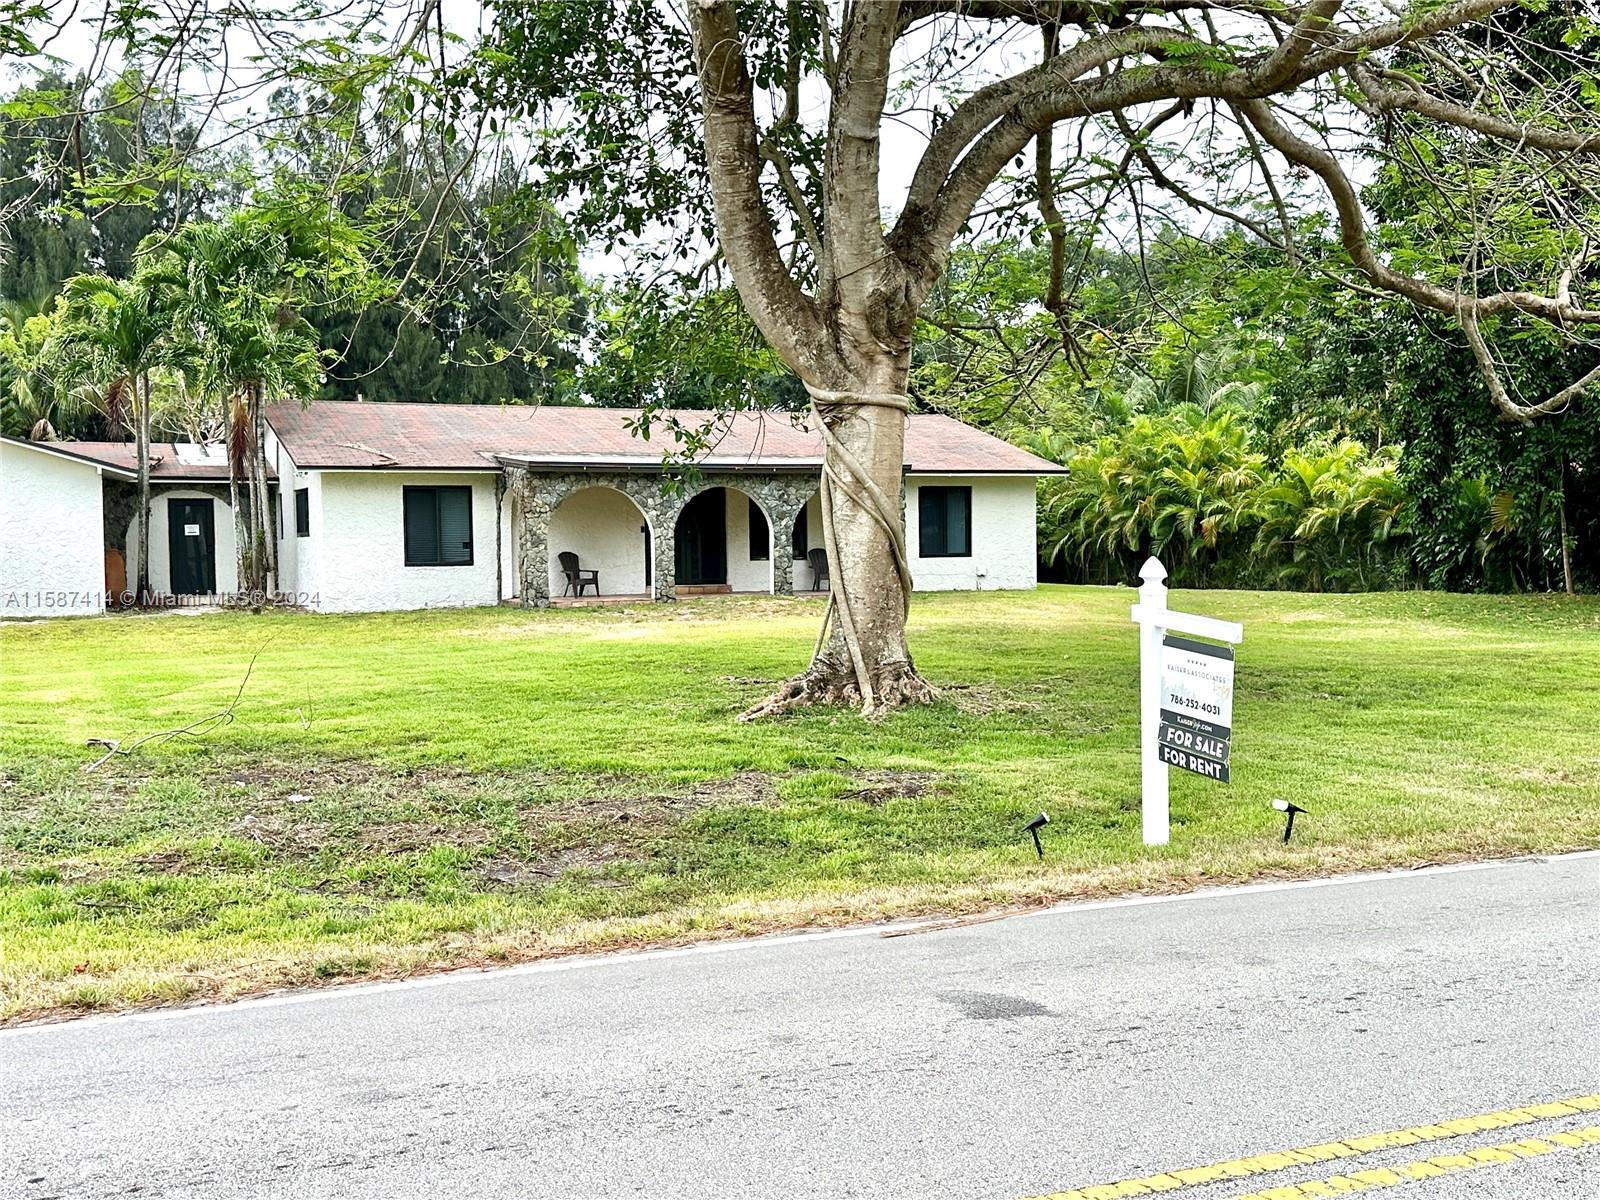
[316, 470, 498, 613]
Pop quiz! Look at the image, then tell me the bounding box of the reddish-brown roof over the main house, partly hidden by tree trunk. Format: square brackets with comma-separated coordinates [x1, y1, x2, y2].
[267, 400, 1062, 475]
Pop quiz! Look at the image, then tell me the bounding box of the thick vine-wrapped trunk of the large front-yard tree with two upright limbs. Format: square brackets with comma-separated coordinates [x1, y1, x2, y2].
[691, 0, 936, 718]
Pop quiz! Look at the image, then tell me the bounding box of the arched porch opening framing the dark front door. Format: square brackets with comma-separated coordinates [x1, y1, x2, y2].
[672, 485, 776, 595]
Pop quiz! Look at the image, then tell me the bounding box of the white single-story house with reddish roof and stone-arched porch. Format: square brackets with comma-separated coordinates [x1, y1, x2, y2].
[0, 402, 1061, 618]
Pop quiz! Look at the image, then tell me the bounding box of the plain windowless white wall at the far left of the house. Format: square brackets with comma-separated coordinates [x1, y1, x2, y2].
[0, 442, 106, 619]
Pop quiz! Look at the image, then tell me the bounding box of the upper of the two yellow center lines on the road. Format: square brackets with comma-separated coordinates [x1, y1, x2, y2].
[1030, 1093, 1600, 1200]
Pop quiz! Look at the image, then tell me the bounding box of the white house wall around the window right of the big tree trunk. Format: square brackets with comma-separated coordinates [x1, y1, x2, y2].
[906, 475, 1038, 592]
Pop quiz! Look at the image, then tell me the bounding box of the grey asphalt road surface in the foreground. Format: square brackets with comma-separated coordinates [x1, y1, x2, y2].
[0, 854, 1600, 1200]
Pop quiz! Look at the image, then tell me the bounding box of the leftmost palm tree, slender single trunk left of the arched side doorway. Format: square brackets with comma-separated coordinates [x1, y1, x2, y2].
[50, 270, 178, 603]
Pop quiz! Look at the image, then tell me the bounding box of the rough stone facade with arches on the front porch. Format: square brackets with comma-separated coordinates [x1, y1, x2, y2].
[506, 467, 819, 608]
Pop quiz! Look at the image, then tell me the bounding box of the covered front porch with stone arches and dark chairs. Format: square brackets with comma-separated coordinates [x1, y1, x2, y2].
[506, 466, 822, 608]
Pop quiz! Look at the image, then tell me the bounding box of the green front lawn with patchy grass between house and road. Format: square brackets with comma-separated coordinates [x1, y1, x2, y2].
[0, 587, 1600, 1019]
